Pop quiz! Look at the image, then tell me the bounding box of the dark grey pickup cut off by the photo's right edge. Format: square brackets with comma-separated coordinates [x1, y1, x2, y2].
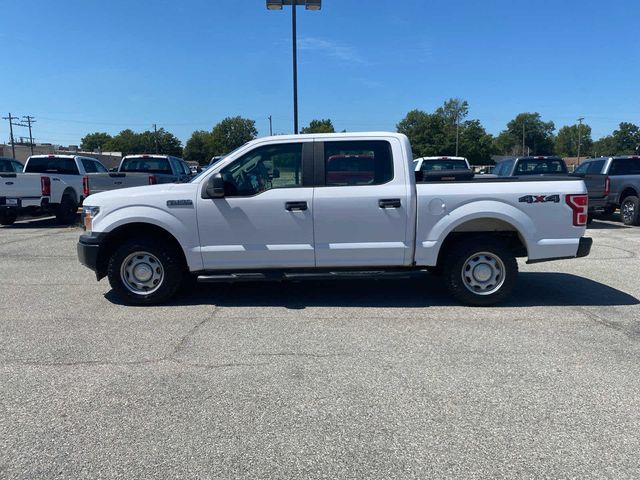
[573, 156, 640, 225]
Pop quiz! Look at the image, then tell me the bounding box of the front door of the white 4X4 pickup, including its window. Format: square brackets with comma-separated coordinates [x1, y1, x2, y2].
[198, 142, 315, 270]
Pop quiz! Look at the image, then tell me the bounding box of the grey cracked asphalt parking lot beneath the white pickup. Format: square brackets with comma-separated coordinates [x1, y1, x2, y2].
[0, 220, 640, 479]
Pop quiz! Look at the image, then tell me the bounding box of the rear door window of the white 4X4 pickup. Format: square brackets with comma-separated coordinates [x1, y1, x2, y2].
[324, 140, 393, 187]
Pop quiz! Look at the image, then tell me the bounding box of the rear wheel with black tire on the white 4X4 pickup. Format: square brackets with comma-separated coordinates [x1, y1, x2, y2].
[443, 237, 518, 307]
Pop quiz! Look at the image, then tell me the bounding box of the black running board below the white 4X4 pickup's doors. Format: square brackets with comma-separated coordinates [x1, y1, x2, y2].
[198, 269, 412, 283]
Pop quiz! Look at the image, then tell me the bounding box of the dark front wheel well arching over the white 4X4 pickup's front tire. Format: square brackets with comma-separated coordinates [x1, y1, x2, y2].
[97, 223, 187, 279]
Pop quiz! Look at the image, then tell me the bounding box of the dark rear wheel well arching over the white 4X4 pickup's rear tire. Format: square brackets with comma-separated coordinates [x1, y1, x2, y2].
[438, 219, 527, 265]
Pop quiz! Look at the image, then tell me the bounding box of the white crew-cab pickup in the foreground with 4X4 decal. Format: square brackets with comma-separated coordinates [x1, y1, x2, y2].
[78, 133, 591, 305]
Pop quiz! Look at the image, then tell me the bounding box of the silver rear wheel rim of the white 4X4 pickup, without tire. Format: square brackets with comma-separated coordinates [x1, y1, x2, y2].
[462, 252, 505, 295]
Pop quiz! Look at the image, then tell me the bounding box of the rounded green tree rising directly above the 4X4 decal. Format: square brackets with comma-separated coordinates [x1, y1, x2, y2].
[495, 112, 555, 155]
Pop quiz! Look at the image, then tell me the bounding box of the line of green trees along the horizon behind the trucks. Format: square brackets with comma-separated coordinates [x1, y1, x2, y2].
[81, 102, 640, 165]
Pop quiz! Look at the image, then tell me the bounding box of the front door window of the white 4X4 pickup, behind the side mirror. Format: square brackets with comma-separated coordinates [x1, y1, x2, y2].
[220, 143, 302, 197]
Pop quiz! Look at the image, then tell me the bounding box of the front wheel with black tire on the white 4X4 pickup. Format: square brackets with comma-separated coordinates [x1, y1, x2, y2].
[107, 238, 185, 305]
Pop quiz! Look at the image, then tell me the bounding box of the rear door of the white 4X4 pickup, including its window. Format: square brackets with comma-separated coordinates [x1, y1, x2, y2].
[313, 138, 412, 267]
